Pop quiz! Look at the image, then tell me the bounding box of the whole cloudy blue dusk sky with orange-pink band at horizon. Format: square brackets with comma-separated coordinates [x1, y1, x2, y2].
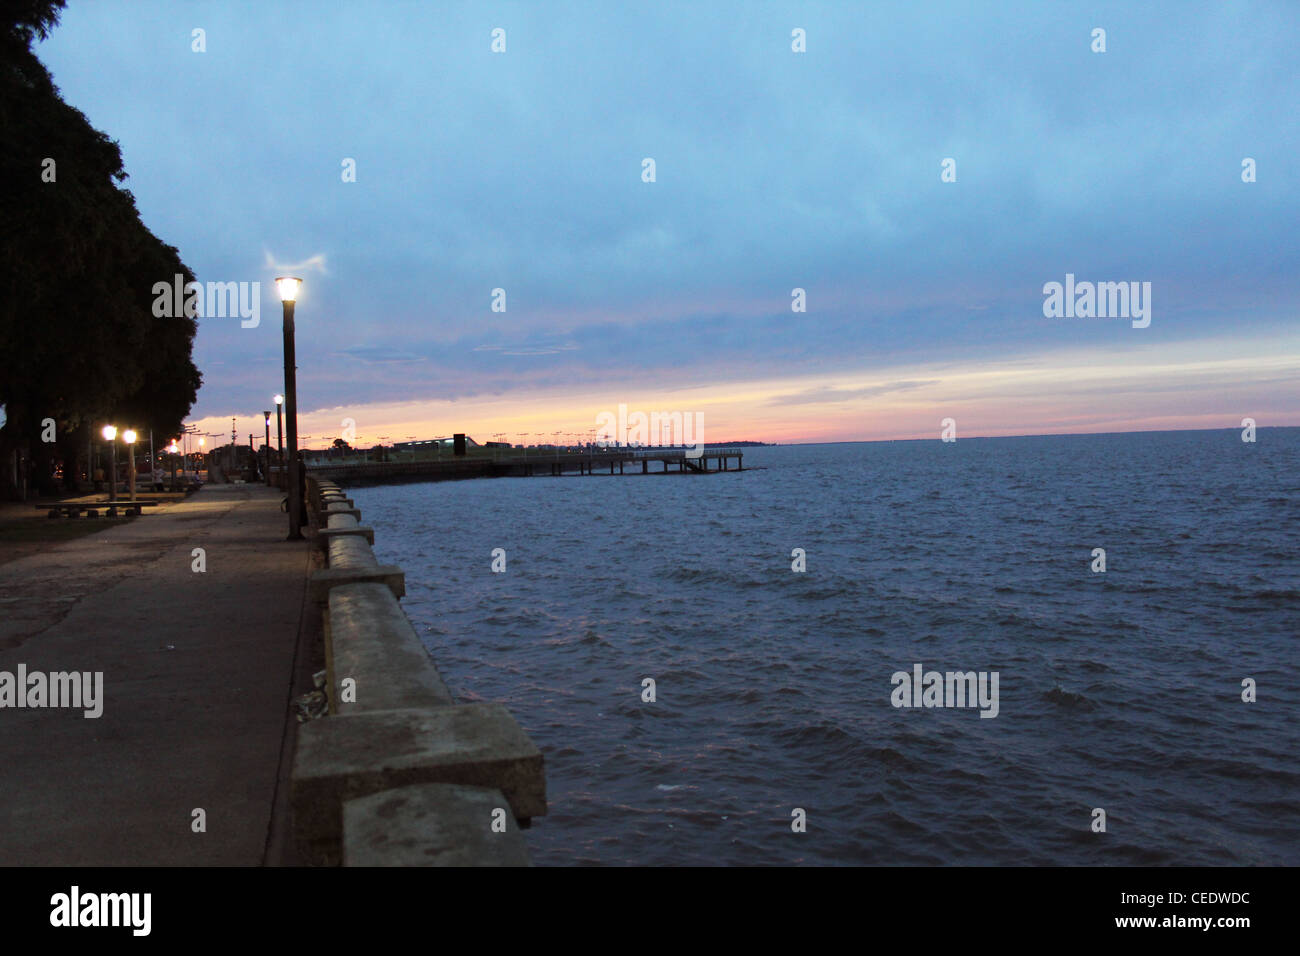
[38, 0, 1300, 447]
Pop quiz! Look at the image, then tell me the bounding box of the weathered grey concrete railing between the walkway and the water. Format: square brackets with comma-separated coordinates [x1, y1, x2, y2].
[290, 477, 546, 866]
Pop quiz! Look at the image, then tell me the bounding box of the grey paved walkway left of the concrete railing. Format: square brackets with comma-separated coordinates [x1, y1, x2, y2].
[0, 485, 309, 866]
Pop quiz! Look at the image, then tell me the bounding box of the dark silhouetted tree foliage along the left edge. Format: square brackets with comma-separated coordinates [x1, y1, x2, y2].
[0, 0, 202, 494]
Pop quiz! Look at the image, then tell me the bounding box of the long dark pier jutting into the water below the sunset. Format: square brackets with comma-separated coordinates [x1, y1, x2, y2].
[307, 447, 745, 484]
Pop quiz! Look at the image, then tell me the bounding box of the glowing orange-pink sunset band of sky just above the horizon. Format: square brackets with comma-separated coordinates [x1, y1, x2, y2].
[189, 338, 1300, 449]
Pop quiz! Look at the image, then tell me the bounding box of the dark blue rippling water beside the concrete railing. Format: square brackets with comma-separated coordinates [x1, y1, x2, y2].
[354, 428, 1300, 865]
